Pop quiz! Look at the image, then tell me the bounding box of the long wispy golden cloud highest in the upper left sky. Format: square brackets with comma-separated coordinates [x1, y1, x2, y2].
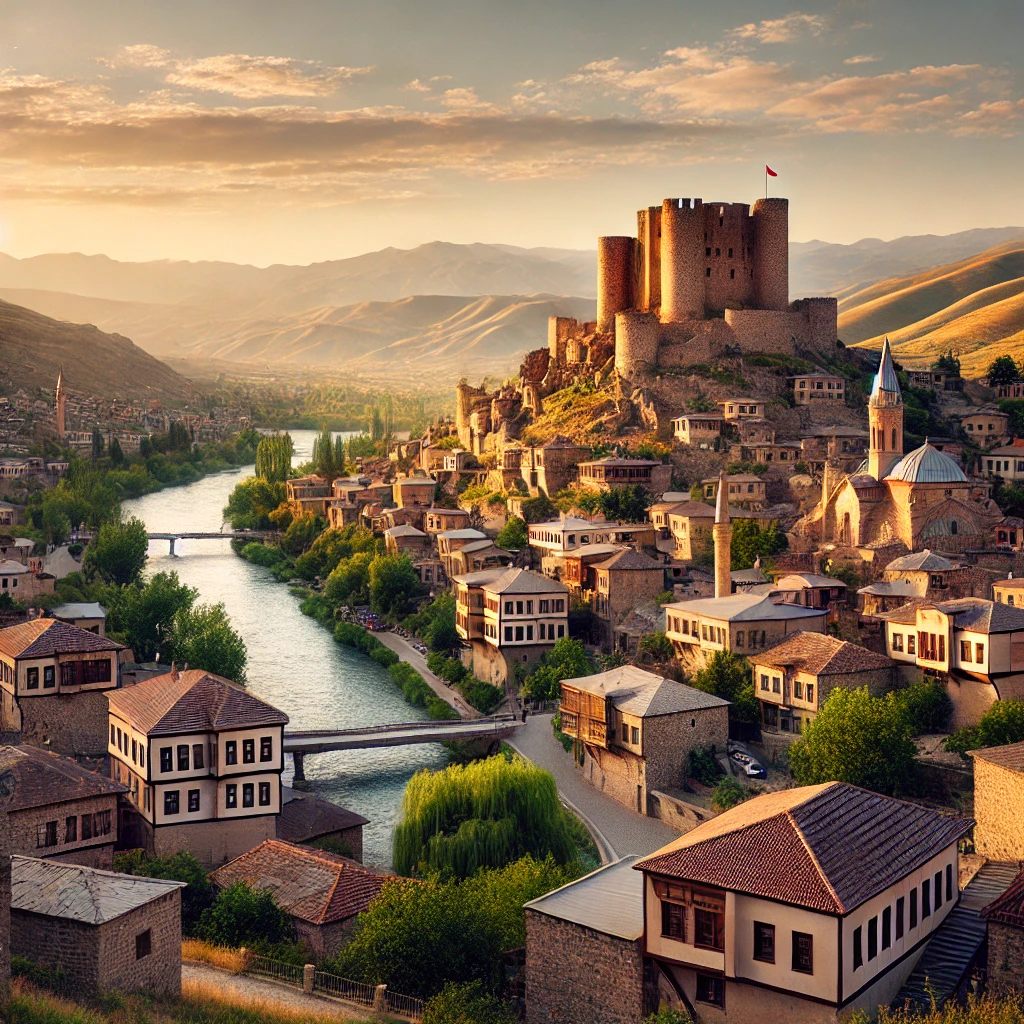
[166, 53, 373, 99]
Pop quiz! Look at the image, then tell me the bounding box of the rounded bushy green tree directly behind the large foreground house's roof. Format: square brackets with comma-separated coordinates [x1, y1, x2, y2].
[790, 686, 916, 795]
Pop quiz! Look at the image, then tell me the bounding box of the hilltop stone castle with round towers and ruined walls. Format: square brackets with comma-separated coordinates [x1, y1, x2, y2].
[456, 199, 838, 453]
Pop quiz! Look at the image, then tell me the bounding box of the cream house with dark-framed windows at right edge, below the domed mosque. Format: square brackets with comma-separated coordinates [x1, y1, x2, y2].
[878, 597, 1024, 729]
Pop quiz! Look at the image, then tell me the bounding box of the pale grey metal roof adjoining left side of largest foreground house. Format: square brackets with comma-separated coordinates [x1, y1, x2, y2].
[524, 856, 643, 940]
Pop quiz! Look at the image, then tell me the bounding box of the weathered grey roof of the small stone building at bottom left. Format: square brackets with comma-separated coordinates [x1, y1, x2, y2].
[10, 854, 185, 925]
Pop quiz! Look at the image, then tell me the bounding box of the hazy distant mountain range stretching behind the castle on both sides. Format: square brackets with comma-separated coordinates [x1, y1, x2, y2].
[0, 227, 1024, 375]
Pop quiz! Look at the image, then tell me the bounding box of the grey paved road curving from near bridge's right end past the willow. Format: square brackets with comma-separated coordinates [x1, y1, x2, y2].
[507, 715, 679, 860]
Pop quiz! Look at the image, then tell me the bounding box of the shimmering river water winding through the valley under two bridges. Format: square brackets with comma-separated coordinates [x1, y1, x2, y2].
[124, 430, 447, 867]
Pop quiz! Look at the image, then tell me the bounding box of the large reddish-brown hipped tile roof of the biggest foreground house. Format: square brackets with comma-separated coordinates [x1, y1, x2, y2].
[637, 782, 973, 914]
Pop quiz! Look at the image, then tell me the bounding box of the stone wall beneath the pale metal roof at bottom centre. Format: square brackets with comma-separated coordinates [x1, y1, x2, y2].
[525, 909, 644, 1024]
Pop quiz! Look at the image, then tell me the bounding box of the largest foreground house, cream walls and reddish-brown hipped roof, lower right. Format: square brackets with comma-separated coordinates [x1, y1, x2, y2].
[636, 782, 972, 1024]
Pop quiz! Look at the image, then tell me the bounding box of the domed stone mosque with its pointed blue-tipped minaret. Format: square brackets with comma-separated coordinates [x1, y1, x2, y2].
[805, 338, 1001, 552]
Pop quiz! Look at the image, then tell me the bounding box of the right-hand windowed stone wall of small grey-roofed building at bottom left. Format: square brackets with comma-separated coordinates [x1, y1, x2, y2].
[98, 889, 181, 997]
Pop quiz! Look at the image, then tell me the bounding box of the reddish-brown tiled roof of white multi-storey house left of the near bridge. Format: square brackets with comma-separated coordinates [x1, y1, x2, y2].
[108, 669, 288, 736]
